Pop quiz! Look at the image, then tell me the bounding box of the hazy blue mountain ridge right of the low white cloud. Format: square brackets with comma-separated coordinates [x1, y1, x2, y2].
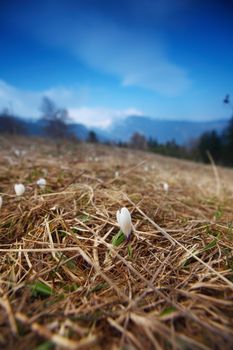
[106, 116, 227, 144]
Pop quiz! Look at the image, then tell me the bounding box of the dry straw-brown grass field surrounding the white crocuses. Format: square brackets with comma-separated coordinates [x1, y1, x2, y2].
[0, 138, 233, 350]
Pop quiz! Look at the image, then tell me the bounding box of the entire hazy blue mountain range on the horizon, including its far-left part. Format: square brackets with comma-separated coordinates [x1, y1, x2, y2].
[4, 116, 228, 144]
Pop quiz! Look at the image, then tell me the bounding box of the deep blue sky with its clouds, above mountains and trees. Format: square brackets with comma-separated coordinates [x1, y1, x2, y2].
[0, 0, 233, 127]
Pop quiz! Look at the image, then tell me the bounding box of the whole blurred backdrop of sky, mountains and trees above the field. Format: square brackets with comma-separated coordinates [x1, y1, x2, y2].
[0, 0, 233, 166]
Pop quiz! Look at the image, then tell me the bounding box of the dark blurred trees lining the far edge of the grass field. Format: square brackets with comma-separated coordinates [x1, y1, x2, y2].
[0, 95, 233, 166]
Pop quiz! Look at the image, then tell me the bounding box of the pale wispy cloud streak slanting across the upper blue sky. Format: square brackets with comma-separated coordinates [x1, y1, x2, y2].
[71, 22, 191, 96]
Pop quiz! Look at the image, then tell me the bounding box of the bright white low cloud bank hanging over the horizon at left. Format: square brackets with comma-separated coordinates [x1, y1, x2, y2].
[0, 80, 143, 128]
